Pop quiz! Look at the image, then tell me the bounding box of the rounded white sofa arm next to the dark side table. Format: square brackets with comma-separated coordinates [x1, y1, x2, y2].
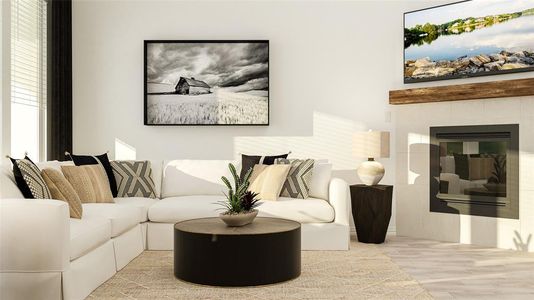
[328, 178, 351, 226]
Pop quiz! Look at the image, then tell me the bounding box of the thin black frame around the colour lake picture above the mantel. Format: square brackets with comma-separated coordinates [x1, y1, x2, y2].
[402, 0, 534, 84]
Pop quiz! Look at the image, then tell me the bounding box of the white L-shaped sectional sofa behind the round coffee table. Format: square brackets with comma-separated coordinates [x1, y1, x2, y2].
[0, 160, 350, 299]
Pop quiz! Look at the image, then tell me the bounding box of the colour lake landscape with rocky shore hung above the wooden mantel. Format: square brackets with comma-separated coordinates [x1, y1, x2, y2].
[404, 0, 534, 83]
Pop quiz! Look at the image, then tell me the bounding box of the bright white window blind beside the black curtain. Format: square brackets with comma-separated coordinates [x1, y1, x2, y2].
[9, 0, 47, 160]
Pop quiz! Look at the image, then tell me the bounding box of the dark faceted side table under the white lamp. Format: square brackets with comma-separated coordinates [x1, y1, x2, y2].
[350, 184, 393, 244]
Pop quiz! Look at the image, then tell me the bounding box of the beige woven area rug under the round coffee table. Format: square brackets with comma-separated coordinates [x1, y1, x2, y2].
[89, 241, 431, 300]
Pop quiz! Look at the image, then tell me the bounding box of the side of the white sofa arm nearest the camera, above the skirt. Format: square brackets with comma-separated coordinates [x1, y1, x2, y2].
[0, 199, 70, 272]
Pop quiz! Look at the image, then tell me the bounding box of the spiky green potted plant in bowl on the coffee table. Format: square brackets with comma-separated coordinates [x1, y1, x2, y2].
[219, 164, 260, 227]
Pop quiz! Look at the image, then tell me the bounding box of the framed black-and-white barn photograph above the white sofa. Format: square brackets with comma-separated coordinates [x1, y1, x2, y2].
[144, 40, 269, 125]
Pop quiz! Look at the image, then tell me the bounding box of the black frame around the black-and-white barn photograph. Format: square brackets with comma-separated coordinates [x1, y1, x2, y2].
[143, 39, 271, 127]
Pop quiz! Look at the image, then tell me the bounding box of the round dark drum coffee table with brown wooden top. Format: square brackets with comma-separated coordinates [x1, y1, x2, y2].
[174, 218, 300, 286]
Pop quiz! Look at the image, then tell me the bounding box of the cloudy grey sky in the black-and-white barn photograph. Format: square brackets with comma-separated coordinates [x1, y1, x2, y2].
[147, 43, 269, 92]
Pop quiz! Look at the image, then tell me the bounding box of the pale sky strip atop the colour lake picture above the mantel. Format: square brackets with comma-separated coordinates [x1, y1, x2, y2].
[405, 0, 534, 28]
